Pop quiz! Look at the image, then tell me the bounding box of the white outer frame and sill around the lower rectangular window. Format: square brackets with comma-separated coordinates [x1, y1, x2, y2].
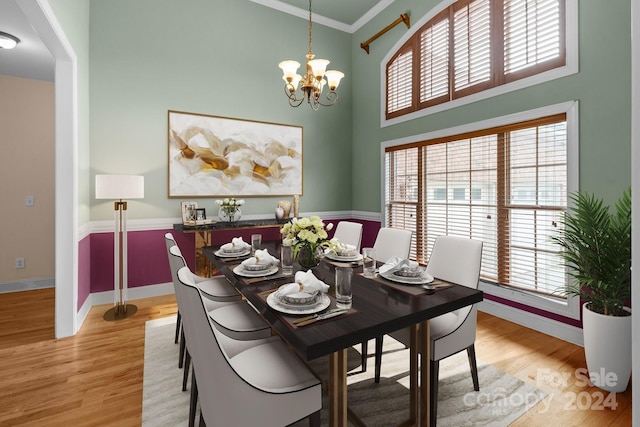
[380, 101, 580, 319]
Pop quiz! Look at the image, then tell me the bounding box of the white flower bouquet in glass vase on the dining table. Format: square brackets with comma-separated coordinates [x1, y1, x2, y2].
[280, 215, 333, 268]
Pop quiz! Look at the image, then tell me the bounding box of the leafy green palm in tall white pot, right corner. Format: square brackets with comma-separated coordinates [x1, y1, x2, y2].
[552, 188, 631, 392]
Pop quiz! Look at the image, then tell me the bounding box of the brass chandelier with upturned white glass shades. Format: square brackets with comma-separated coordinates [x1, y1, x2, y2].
[278, 0, 344, 110]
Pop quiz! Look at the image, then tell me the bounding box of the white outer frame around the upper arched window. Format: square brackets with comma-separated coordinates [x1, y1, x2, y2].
[380, 0, 579, 128]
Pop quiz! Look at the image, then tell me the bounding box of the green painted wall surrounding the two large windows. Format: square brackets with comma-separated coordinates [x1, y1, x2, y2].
[351, 0, 631, 212]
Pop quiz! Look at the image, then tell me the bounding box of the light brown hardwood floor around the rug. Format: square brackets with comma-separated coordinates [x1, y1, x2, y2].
[0, 289, 631, 427]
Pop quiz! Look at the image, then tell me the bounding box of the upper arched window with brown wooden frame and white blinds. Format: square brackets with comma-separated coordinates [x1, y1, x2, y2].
[385, 0, 566, 119]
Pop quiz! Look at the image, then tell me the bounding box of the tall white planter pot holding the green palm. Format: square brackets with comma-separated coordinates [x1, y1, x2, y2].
[582, 304, 631, 393]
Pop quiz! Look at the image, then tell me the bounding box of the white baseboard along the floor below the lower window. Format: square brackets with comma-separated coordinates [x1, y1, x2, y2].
[478, 300, 584, 347]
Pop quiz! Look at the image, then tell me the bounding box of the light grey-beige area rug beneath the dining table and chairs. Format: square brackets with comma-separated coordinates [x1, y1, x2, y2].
[142, 317, 545, 427]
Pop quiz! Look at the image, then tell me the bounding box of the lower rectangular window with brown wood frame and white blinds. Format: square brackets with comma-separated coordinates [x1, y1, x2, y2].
[385, 113, 568, 296]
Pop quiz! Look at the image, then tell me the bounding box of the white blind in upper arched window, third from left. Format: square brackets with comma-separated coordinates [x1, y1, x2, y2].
[453, 0, 491, 90]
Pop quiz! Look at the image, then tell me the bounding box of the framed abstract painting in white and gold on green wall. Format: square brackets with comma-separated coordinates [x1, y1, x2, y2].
[168, 110, 302, 197]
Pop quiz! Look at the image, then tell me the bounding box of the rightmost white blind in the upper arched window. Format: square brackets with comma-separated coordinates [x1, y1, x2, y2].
[504, 0, 561, 74]
